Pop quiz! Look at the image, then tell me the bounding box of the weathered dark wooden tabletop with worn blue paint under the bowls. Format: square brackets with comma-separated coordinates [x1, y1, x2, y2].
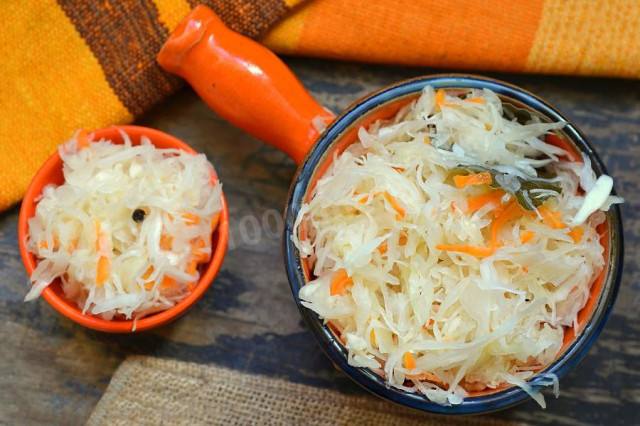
[0, 59, 640, 425]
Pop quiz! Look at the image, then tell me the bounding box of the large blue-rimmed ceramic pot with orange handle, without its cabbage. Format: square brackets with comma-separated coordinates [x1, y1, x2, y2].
[158, 6, 623, 414]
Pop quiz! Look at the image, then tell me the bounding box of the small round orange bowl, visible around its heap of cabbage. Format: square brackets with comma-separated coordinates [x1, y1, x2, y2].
[18, 126, 229, 333]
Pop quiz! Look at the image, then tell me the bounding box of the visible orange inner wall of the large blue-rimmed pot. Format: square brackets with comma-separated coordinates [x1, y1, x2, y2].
[300, 94, 611, 397]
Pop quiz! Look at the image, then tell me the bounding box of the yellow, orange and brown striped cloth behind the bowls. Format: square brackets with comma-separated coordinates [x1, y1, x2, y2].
[0, 0, 640, 210]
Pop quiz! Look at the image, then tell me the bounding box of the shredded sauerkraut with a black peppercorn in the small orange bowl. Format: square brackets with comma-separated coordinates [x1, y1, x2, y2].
[25, 131, 222, 326]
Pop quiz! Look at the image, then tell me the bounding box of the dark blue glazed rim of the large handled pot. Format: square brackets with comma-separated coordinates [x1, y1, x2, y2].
[283, 74, 624, 415]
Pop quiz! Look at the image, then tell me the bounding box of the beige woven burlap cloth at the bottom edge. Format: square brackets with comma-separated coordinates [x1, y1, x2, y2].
[87, 356, 515, 426]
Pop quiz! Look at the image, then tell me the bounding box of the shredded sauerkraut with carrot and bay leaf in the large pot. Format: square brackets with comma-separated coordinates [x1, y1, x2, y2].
[292, 87, 622, 406]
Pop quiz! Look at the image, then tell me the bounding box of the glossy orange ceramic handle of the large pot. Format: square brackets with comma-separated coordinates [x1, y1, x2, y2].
[158, 6, 334, 164]
